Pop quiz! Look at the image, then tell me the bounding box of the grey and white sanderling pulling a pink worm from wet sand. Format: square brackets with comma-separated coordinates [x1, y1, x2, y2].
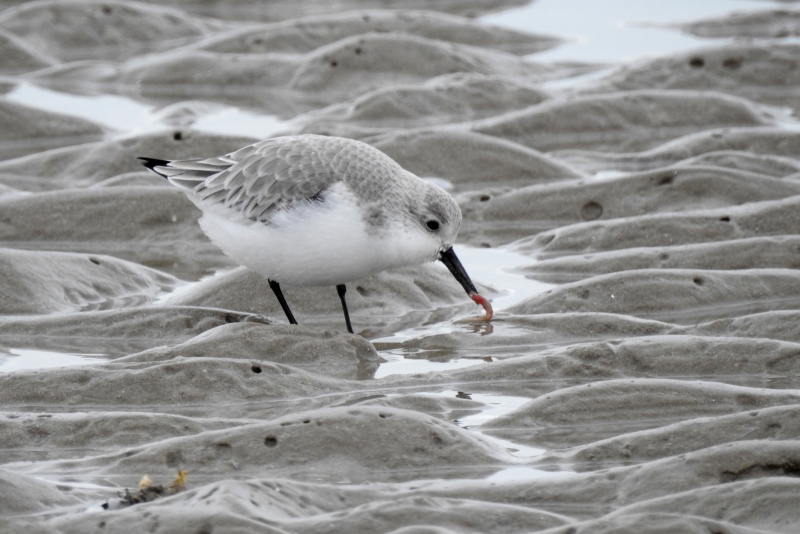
[139, 135, 492, 332]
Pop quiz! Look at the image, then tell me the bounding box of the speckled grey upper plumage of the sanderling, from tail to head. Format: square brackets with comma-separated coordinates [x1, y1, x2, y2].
[148, 135, 446, 226]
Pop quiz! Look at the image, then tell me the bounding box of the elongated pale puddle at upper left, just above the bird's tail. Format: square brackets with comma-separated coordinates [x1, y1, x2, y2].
[5, 83, 289, 139]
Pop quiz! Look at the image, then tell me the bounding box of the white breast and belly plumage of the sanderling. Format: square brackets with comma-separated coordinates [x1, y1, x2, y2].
[199, 183, 441, 286]
